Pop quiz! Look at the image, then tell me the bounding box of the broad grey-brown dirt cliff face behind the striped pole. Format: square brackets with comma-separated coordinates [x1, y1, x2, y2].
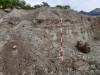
[0, 8, 100, 75]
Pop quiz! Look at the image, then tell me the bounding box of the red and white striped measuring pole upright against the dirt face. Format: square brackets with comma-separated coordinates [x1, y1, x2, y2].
[59, 18, 64, 63]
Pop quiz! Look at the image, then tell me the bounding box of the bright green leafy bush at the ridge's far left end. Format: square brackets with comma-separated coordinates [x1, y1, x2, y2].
[0, 0, 32, 9]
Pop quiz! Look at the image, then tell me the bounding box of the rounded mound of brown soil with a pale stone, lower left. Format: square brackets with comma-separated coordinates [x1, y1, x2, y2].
[1, 40, 33, 75]
